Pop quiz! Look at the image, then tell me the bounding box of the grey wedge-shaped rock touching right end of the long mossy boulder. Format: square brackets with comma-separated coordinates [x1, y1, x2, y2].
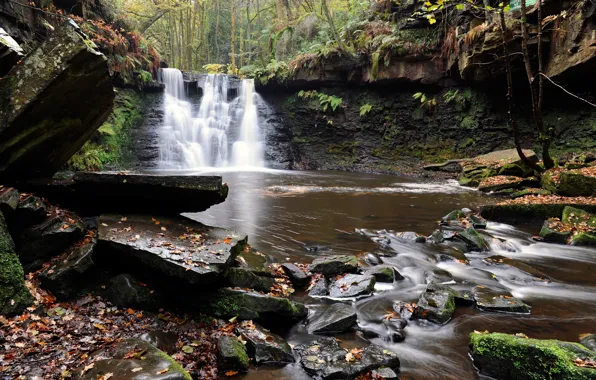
[307, 303, 356, 335]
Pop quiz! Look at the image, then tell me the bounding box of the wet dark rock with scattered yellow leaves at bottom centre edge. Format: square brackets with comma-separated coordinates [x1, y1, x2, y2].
[295, 338, 400, 380]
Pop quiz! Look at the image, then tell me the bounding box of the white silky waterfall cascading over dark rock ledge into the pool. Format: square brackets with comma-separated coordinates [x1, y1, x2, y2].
[159, 69, 264, 169]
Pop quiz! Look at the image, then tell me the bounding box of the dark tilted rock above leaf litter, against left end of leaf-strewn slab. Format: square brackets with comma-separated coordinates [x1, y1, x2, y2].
[38, 240, 95, 299]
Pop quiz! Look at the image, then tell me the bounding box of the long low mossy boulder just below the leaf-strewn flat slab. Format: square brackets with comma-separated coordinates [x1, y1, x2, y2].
[205, 288, 307, 324]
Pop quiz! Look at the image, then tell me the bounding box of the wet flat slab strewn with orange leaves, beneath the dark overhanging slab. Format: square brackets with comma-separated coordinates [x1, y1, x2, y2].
[96, 215, 248, 285]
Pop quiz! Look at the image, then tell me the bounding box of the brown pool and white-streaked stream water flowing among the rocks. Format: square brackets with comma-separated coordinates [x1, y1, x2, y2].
[184, 172, 596, 380]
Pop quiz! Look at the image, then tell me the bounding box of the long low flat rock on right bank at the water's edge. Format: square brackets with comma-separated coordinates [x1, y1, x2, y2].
[481, 203, 596, 224]
